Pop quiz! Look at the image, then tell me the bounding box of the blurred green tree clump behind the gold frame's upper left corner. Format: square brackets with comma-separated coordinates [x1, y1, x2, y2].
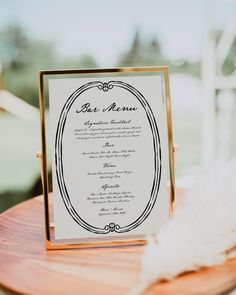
[0, 25, 97, 106]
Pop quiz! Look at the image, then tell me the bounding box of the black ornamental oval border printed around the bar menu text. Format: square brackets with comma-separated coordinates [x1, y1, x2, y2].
[55, 81, 162, 234]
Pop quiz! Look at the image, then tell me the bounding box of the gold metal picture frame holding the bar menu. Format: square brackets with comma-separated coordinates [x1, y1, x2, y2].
[37, 66, 175, 250]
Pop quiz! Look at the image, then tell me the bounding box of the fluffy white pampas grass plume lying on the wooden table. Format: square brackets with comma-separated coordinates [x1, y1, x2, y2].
[129, 161, 236, 295]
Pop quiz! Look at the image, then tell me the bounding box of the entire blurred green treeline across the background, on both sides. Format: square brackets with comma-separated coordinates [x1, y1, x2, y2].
[0, 24, 236, 106]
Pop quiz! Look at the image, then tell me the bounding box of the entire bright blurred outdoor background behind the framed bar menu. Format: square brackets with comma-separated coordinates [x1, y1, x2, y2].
[0, 0, 236, 211]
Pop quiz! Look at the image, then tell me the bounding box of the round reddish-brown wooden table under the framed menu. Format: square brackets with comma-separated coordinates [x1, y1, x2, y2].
[0, 192, 236, 295]
